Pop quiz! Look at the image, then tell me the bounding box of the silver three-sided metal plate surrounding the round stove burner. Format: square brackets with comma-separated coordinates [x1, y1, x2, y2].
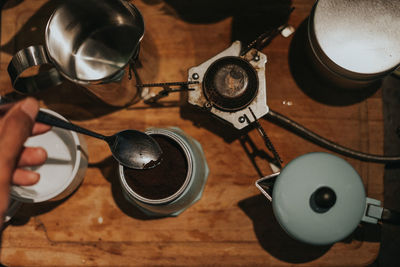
[188, 41, 269, 129]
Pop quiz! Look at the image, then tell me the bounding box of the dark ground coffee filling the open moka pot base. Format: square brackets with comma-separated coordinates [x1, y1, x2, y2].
[124, 134, 188, 199]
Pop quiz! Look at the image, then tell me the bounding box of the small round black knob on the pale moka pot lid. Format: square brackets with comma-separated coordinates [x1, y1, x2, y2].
[310, 186, 336, 213]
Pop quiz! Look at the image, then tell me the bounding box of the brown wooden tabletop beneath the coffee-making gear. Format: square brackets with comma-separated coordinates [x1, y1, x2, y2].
[0, 0, 384, 266]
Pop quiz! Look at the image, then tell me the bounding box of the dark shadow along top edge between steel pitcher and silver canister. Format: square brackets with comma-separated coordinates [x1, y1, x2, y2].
[143, 0, 292, 45]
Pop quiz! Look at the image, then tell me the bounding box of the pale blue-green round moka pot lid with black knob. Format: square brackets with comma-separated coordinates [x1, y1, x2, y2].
[272, 152, 366, 245]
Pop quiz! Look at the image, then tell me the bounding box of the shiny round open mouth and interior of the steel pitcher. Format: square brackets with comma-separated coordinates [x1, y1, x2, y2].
[45, 0, 144, 83]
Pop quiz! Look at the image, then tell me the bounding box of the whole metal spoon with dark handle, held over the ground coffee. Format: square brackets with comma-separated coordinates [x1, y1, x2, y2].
[36, 111, 162, 169]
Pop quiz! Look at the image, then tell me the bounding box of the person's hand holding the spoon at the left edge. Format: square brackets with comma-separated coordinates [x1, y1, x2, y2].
[0, 98, 50, 226]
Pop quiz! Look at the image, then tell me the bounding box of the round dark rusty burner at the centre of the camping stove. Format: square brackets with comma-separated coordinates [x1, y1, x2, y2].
[203, 57, 258, 111]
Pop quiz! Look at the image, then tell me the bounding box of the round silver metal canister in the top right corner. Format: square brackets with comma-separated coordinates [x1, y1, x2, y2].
[308, 0, 400, 85]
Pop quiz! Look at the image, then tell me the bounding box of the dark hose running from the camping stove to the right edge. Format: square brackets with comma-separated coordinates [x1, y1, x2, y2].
[264, 109, 400, 163]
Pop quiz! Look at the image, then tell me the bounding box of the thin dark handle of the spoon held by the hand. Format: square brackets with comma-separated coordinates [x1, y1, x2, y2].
[36, 111, 106, 140]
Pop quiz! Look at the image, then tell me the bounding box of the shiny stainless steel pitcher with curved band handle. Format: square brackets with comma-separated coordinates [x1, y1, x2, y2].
[8, 0, 144, 106]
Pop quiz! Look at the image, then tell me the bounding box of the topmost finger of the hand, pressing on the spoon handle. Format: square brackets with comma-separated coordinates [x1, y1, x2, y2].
[0, 98, 39, 181]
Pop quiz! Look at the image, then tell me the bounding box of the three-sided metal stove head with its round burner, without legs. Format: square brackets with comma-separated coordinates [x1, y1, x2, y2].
[188, 41, 269, 129]
